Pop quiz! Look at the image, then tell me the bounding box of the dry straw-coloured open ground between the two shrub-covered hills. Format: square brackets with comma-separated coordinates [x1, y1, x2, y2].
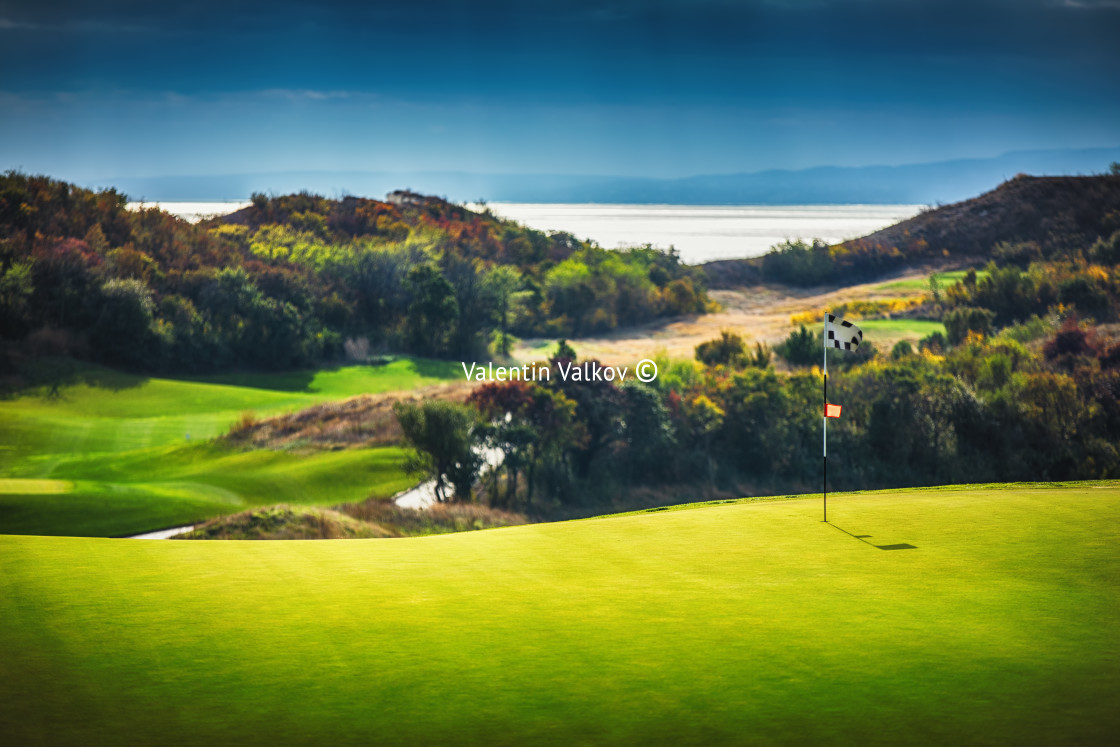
[513, 271, 928, 365]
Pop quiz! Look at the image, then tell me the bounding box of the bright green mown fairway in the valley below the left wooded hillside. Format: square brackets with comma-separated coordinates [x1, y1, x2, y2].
[0, 358, 461, 536]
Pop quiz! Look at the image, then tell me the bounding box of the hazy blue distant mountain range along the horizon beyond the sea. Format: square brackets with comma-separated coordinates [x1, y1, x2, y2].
[98, 148, 1120, 205]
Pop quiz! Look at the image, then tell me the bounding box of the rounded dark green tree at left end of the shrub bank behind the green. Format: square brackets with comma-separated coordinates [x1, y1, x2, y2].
[393, 400, 482, 503]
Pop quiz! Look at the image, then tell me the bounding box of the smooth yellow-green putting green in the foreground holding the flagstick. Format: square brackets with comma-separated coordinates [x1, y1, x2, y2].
[0, 482, 1120, 745]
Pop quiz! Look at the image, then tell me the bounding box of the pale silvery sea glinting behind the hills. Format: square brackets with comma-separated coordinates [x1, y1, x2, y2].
[129, 202, 924, 264]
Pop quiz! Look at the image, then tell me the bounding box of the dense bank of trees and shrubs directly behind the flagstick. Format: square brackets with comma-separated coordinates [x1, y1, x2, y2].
[392, 314, 1120, 515]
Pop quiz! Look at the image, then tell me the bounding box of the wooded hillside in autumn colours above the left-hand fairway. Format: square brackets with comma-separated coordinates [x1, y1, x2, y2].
[0, 171, 711, 373]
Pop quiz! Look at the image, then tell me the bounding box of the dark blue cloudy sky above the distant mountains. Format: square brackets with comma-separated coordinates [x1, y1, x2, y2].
[0, 0, 1120, 181]
